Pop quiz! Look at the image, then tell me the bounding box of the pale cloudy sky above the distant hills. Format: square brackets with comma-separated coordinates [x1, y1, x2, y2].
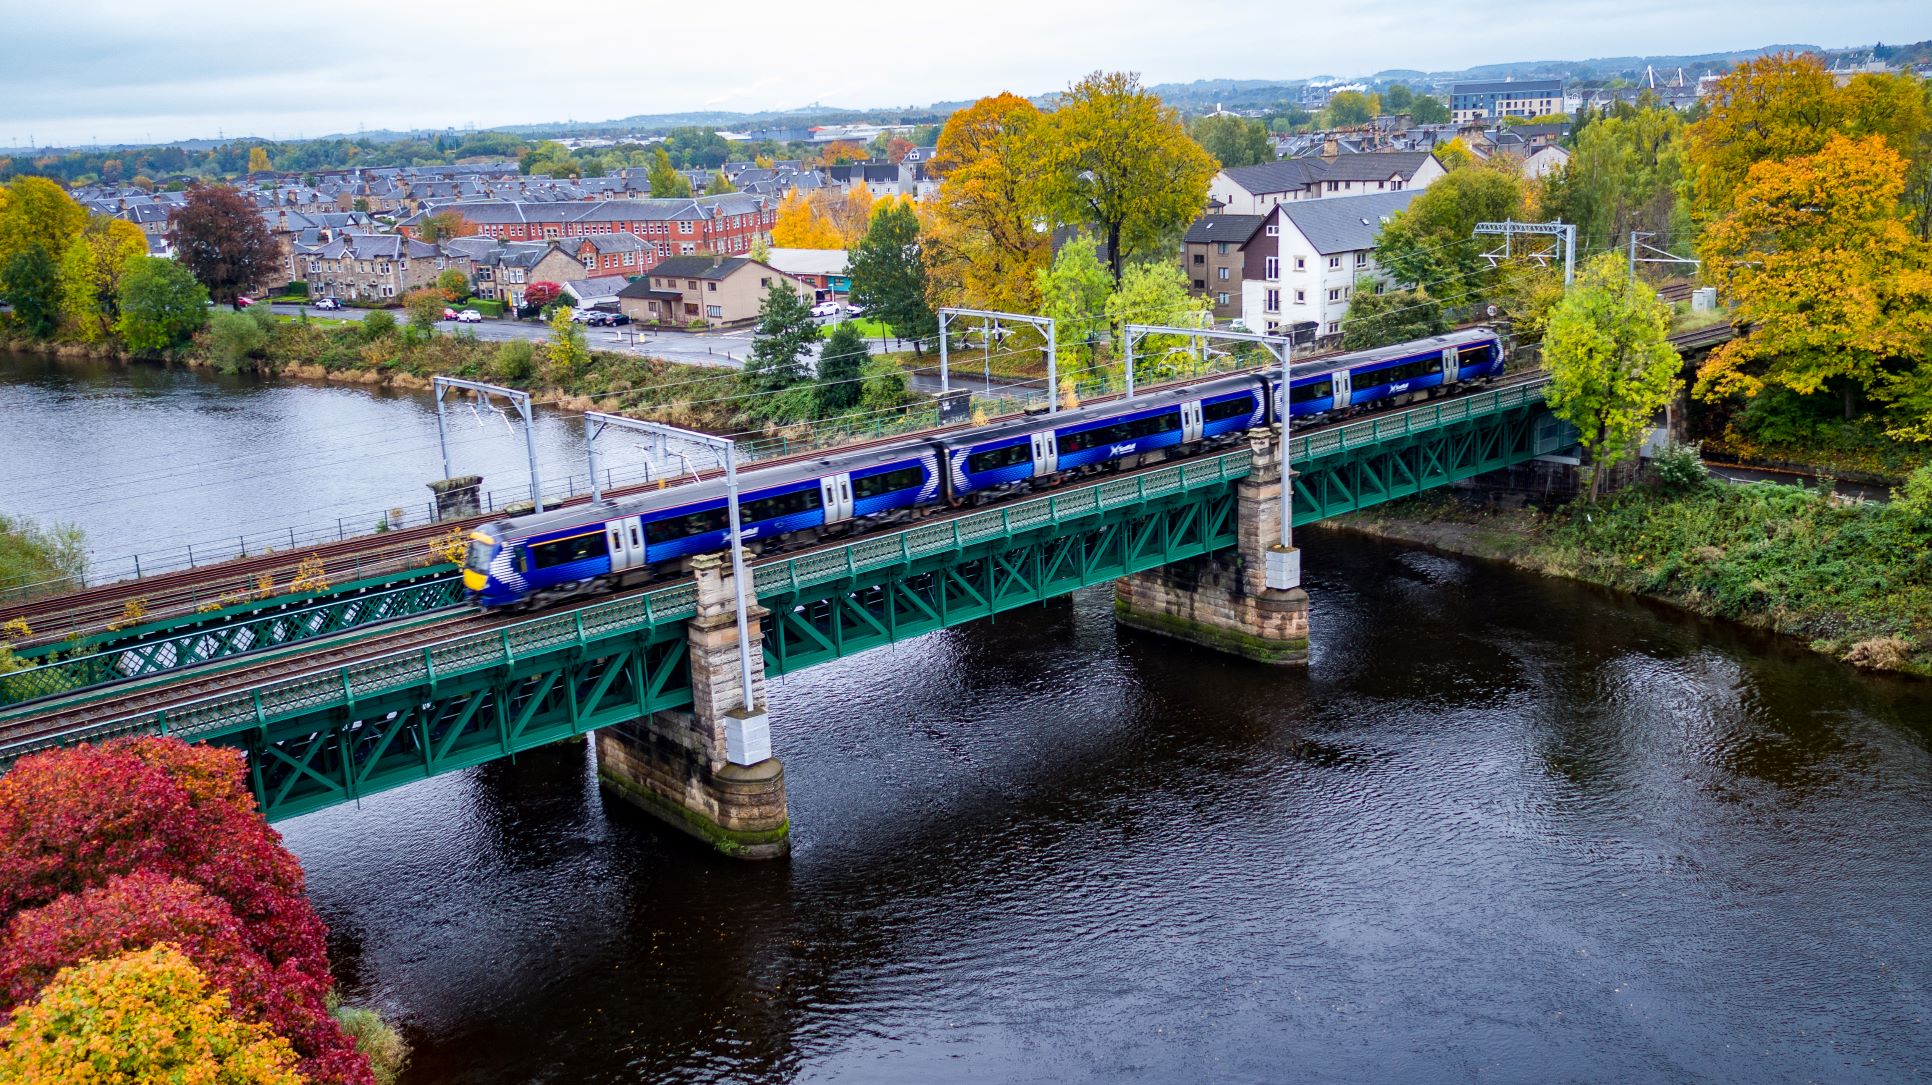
[0, 0, 1932, 147]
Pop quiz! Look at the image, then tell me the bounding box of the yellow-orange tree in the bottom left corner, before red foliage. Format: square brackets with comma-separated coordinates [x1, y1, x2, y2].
[0, 946, 301, 1085]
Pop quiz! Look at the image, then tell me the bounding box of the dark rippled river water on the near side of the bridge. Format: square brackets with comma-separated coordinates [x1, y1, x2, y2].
[0, 351, 1932, 1085]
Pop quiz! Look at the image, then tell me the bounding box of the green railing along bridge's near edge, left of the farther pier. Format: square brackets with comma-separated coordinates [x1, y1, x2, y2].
[0, 450, 1252, 766]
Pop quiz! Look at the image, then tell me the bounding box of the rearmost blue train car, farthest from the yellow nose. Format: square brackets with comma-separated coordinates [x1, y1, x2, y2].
[1267, 328, 1503, 421]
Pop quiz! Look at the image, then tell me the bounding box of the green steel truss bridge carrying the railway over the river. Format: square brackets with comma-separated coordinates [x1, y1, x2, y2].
[0, 378, 1575, 819]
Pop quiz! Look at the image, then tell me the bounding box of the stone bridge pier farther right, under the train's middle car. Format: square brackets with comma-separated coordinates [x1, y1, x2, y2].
[1113, 431, 1308, 666]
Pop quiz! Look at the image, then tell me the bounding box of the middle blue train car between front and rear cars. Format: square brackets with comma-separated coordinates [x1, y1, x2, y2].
[937, 376, 1267, 504]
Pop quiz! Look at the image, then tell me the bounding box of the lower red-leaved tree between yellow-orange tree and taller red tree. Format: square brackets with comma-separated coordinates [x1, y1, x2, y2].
[0, 871, 373, 1085]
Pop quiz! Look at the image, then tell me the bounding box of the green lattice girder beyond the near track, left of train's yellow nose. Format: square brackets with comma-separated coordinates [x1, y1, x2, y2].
[0, 575, 462, 707]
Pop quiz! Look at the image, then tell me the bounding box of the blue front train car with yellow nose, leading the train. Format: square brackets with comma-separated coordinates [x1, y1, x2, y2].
[464, 442, 941, 608]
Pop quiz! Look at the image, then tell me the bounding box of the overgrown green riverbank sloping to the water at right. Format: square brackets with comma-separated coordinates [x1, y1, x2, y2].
[1335, 469, 1932, 678]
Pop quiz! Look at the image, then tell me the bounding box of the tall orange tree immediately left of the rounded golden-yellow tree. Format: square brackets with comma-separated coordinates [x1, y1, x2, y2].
[925, 93, 1053, 313]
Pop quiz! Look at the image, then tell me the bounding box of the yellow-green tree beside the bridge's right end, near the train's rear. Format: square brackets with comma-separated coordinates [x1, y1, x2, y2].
[1544, 253, 1683, 500]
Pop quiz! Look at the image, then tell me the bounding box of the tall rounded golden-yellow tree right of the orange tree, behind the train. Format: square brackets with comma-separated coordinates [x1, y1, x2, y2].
[1037, 71, 1215, 282]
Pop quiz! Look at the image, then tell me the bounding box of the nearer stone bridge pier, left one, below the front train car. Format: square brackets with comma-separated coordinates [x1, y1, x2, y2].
[597, 554, 790, 859]
